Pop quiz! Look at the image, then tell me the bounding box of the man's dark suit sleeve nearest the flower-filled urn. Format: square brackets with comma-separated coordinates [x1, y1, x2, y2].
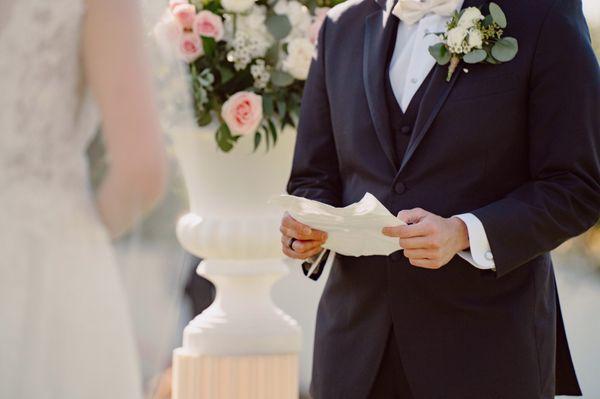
[287, 19, 341, 206]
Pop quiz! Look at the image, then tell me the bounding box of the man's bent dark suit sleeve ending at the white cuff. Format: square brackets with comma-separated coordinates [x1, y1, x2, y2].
[473, 0, 600, 277]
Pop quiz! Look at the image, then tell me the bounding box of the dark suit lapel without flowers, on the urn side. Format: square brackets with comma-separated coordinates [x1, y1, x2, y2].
[363, 0, 399, 170]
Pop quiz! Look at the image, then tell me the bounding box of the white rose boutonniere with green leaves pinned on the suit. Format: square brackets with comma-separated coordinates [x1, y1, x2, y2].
[429, 3, 519, 81]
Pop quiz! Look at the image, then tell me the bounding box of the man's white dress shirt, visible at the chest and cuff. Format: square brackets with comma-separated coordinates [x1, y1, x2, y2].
[389, 2, 495, 269]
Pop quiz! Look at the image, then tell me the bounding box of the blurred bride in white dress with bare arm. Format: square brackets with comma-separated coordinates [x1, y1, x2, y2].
[0, 0, 166, 399]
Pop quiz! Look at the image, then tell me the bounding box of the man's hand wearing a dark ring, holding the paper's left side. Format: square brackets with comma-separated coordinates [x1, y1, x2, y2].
[279, 212, 327, 260]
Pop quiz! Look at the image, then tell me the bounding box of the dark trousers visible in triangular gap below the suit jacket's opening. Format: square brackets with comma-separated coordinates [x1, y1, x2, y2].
[369, 329, 413, 399]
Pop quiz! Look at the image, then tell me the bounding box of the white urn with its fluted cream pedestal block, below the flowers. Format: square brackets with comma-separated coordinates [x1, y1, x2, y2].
[171, 125, 301, 399]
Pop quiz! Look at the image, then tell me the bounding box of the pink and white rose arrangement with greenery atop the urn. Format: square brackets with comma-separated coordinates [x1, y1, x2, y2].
[154, 0, 339, 152]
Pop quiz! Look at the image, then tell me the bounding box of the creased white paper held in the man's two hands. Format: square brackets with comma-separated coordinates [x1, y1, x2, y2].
[271, 193, 406, 256]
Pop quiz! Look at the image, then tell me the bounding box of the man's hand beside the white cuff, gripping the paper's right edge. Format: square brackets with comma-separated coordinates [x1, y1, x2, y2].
[382, 208, 469, 269]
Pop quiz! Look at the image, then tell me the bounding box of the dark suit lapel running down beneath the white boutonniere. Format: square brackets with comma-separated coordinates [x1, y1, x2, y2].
[398, 0, 481, 173]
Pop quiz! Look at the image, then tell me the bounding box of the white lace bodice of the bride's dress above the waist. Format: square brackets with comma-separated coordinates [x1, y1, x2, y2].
[0, 0, 97, 195]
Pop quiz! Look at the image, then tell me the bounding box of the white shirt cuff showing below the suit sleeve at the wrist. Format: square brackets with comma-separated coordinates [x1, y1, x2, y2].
[455, 213, 496, 270]
